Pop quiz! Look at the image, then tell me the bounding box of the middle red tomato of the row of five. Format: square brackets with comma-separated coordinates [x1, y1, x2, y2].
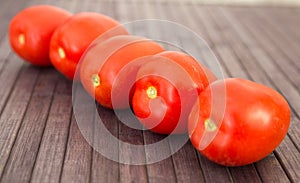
[80, 35, 164, 109]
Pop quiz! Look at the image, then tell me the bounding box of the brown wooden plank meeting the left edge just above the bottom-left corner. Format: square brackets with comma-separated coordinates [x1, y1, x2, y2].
[0, 61, 39, 175]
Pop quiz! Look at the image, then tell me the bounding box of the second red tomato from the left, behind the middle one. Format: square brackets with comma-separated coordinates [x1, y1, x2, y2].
[50, 12, 128, 79]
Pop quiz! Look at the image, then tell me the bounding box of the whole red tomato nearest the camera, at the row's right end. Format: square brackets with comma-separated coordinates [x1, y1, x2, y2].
[189, 78, 290, 166]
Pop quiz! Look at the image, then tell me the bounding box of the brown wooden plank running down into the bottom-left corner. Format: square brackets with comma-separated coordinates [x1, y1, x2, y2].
[2, 68, 58, 182]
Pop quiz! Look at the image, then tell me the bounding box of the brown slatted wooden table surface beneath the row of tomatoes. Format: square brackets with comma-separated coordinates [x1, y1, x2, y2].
[0, 0, 300, 182]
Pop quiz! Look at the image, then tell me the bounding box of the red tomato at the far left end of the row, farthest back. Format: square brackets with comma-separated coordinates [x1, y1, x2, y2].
[9, 5, 71, 66]
